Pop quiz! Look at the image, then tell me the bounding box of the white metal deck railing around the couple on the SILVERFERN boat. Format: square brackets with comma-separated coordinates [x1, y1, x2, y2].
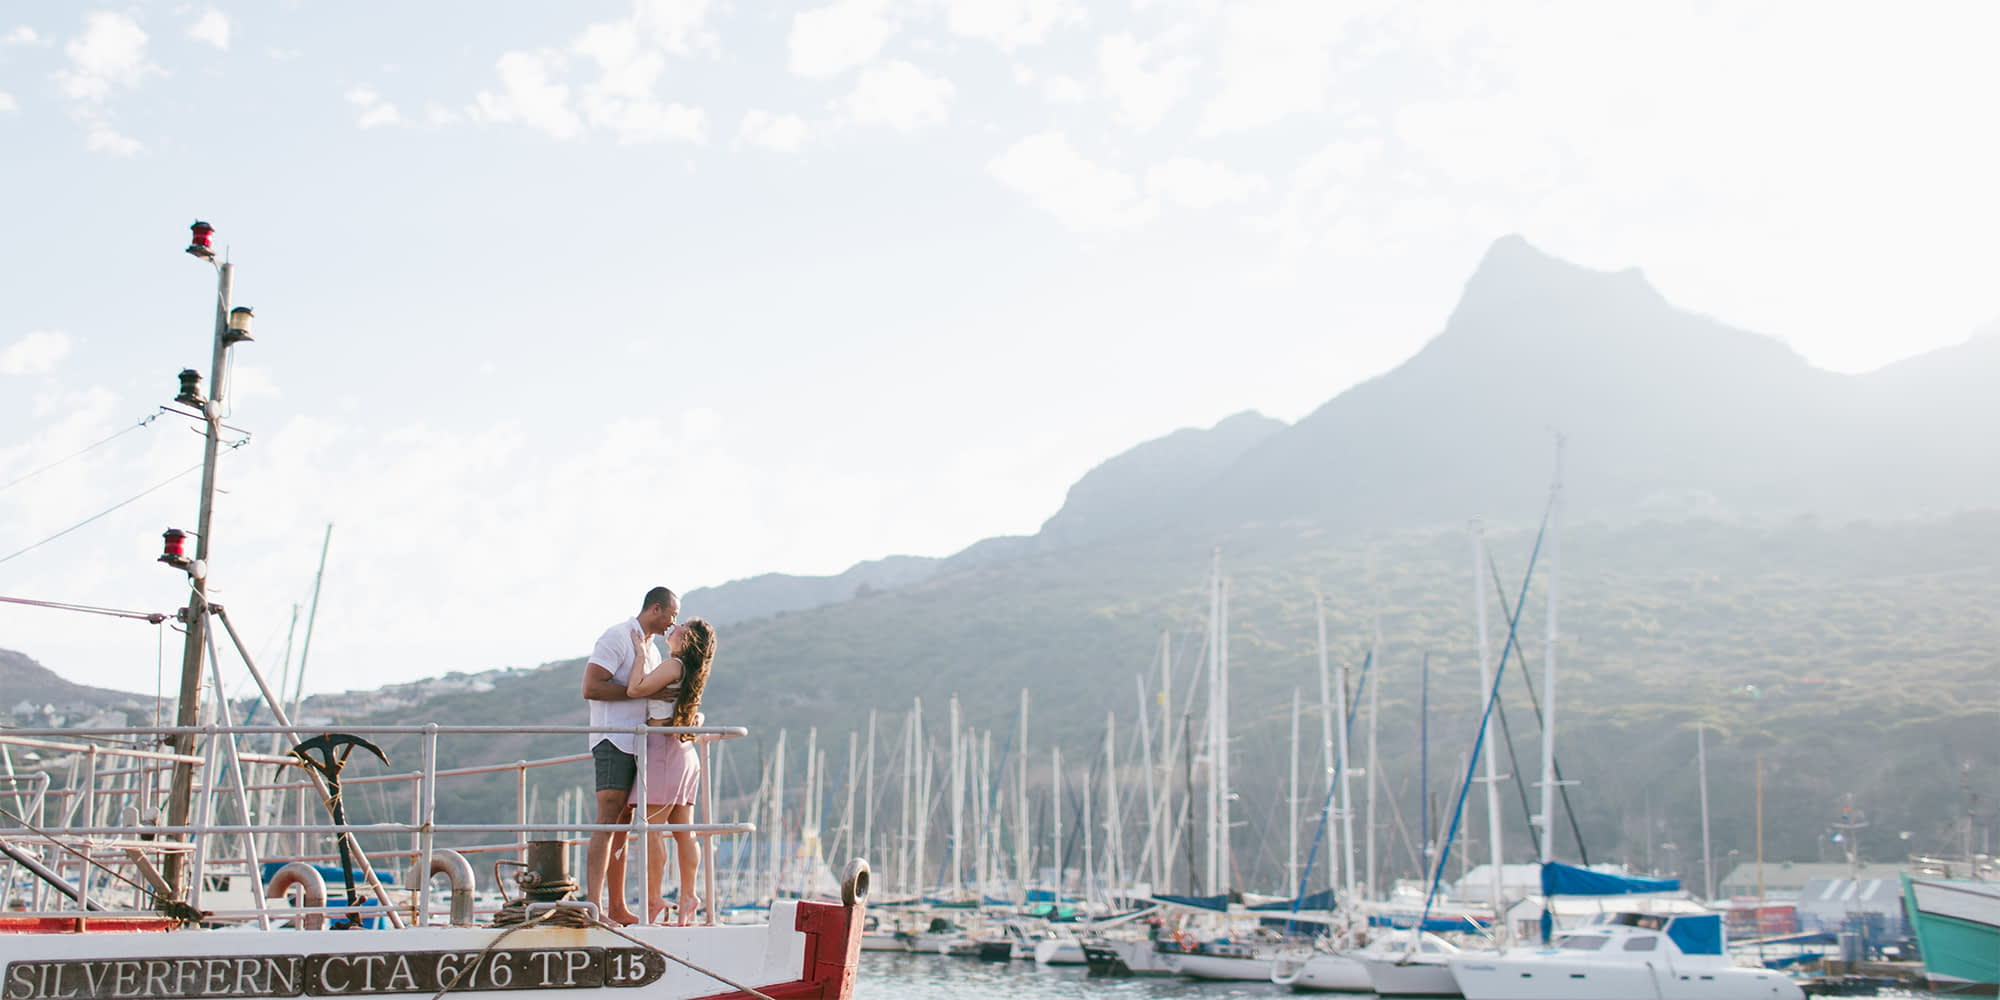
[0, 724, 756, 928]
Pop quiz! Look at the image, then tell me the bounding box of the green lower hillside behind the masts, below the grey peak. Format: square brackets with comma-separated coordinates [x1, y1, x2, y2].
[360, 512, 2000, 886]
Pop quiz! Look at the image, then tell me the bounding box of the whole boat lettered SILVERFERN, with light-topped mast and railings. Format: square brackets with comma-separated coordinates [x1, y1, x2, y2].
[0, 222, 870, 1000]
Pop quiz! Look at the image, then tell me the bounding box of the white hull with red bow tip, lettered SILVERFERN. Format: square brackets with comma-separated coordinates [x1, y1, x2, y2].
[0, 900, 860, 1000]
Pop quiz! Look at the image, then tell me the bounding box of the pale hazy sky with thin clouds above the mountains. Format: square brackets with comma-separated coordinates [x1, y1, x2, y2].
[0, 0, 2000, 704]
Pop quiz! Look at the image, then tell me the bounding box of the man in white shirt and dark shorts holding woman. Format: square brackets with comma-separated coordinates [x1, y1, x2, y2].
[584, 586, 680, 924]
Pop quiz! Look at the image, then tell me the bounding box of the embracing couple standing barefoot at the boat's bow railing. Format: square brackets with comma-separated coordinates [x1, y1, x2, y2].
[584, 586, 716, 924]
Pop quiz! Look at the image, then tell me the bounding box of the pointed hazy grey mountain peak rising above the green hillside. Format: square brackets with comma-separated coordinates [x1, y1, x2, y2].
[1190, 236, 1968, 530]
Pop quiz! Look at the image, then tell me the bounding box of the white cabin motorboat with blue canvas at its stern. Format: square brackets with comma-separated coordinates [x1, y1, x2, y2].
[1446, 912, 1806, 1000]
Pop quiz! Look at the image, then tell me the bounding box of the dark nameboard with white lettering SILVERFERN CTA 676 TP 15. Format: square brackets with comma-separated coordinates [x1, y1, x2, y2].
[0, 948, 666, 1000]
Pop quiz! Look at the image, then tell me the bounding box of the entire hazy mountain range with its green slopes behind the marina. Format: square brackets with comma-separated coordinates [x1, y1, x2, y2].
[19, 238, 2000, 886]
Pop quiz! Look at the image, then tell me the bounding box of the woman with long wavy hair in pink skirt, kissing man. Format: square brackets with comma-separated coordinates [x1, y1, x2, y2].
[626, 618, 716, 924]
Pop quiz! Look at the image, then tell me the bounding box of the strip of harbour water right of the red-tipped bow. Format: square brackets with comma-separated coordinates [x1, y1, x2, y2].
[854, 952, 1942, 1000]
